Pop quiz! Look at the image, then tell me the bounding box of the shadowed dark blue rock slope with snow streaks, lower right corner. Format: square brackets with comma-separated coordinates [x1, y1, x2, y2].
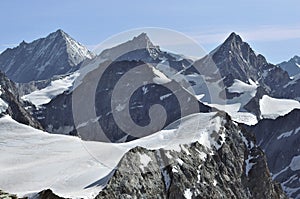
[249, 109, 300, 198]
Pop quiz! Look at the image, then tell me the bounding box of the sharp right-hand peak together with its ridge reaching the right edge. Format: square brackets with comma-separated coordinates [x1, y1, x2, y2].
[195, 33, 300, 116]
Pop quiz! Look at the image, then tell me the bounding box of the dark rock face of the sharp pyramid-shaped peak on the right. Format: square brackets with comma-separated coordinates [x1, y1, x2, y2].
[211, 33, 290, 97]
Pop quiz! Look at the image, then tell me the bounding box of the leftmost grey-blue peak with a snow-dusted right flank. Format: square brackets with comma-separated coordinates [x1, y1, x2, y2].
[0, 30, 94, 83]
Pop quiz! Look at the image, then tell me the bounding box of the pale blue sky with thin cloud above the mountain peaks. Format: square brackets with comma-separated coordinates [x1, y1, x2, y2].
[0, 0, 300, 63]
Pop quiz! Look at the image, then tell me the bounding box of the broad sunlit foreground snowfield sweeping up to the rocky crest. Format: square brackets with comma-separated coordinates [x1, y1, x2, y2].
[0, 113, 225, 198]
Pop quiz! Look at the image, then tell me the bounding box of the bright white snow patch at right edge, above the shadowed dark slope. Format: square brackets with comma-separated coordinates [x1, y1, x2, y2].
[259, 95, 300, 119]
